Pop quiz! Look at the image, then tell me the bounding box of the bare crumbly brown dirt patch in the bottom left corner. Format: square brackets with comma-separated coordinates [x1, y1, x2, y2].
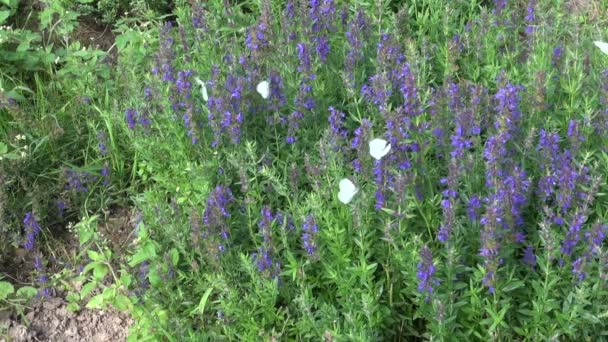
[0, 297, 133, 342]
